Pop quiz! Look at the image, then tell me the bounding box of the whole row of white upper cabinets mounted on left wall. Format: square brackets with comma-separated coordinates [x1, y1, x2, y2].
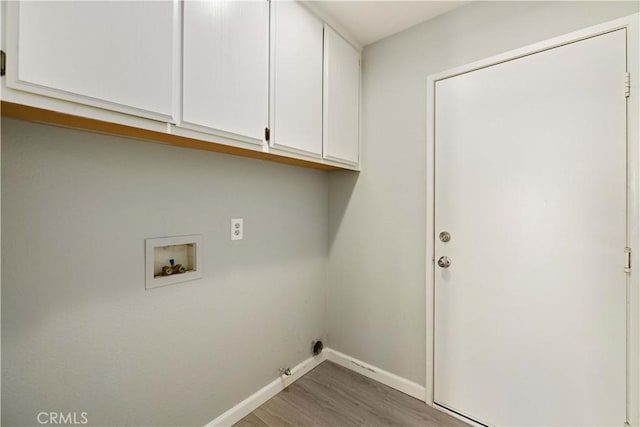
[0, 0, 360, 170]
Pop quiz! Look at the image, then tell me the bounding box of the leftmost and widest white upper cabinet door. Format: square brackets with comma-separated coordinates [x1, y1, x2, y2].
[7, 1, 179, 121]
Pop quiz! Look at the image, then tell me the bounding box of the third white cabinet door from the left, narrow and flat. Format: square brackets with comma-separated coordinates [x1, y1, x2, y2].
[271, 1, 323, 158]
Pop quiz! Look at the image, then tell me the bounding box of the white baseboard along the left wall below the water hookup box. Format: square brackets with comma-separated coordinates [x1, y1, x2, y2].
[205, 352, 326, 427]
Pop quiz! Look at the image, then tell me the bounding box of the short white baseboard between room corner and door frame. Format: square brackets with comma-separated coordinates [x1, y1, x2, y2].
[322, 348, 426, 402]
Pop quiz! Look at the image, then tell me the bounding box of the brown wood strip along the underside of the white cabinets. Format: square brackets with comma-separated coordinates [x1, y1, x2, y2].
[0, 101, 341, 170]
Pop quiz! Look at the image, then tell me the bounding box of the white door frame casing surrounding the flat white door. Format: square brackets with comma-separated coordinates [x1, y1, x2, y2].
[425, 13, 640, 426]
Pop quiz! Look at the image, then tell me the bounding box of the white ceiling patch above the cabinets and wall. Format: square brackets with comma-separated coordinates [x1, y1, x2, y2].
[312, 0, 469, 46]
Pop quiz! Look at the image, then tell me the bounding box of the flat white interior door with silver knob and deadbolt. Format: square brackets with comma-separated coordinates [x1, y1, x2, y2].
[434, 29, 627, 426]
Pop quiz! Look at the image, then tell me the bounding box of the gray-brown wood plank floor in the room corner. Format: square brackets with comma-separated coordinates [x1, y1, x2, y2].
[234, 361, 469, 427]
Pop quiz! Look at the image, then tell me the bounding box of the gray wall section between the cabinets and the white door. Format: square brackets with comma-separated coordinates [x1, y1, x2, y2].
[328, 2, 638, 385]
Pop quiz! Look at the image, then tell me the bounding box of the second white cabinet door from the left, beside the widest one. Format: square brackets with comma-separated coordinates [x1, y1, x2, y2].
[182, 0, 269, 144]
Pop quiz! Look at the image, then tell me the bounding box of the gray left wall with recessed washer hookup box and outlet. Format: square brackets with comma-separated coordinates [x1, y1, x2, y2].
[2, 119, 328, 426]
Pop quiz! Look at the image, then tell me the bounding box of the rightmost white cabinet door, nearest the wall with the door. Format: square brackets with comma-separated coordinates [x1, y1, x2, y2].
[323, 26, 360, 165]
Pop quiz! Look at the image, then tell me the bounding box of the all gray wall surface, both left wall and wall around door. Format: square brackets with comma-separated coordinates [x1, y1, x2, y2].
[2, 2, 638, 426]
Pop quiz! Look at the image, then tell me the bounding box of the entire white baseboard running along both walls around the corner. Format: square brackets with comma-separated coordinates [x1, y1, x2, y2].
[205, 348, 426, 427]
